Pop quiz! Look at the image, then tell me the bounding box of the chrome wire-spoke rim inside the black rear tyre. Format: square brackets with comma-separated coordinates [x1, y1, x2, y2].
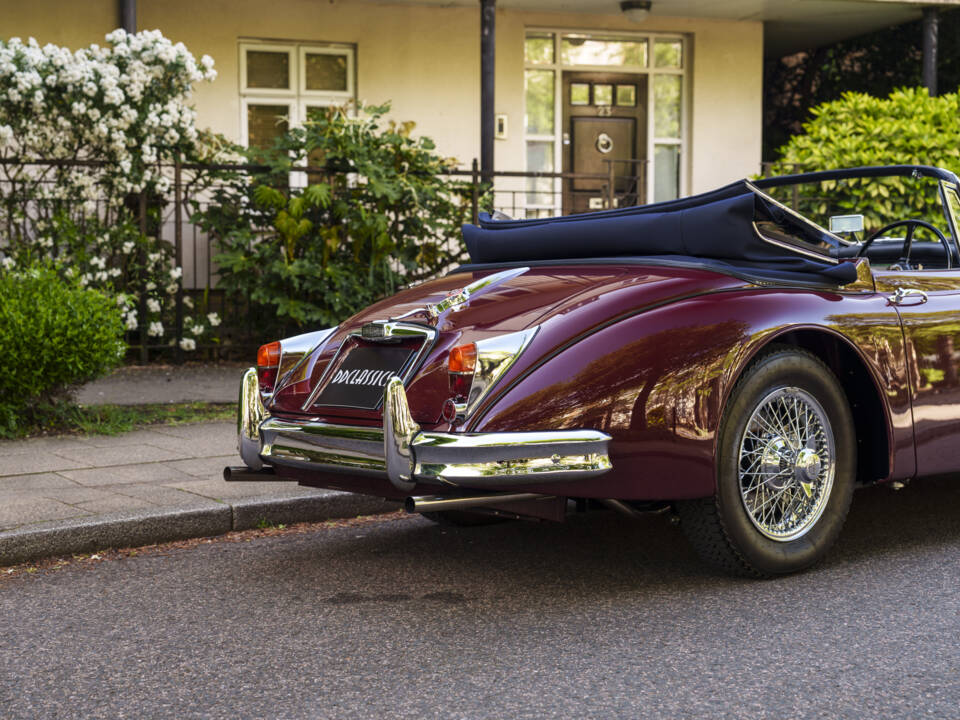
[738, 387, 836, 542]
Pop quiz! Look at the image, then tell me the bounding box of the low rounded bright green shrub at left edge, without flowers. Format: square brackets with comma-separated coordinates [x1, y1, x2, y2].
[0, 264, 125, 435]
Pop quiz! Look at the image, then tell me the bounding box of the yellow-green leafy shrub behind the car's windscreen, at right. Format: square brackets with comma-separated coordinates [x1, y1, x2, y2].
[771, 88, 960, 230]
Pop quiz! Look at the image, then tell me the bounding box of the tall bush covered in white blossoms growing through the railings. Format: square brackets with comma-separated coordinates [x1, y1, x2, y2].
[0, 30, 219, 350]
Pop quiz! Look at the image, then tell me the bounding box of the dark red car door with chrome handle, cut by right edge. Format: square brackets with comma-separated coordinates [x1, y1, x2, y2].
[874, 183, 960, 476]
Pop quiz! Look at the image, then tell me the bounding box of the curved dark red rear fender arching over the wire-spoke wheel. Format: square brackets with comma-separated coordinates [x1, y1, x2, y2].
[470, 288, 912, 500]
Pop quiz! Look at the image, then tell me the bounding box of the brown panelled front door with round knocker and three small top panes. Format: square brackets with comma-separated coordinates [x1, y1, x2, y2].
[562, 72, 647, 215]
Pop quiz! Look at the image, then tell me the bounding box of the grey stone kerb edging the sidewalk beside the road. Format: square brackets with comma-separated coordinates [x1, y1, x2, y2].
[0, 490, 397, 566]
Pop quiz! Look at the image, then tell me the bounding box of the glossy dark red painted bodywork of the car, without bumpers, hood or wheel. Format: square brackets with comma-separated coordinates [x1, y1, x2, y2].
[227, 163, 960, 572]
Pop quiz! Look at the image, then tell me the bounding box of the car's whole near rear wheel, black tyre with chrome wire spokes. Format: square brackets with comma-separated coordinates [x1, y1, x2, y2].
[677, 346, 857, 577]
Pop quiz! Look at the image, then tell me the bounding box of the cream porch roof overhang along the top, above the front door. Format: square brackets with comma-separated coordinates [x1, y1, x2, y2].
[374, 0, 960, 57]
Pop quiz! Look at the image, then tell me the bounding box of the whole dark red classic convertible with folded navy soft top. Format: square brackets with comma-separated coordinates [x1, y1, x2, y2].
[224, 166, 960, 577]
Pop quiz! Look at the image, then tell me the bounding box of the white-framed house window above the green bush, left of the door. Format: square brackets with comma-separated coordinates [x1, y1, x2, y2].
[239, 40, 356, 147]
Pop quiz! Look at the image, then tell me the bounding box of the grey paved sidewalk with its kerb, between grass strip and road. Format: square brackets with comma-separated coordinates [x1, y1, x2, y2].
[0, 420, 397, 566]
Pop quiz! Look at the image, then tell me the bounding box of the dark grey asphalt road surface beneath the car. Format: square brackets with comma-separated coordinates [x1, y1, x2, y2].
[0, 480, 960, 719]
